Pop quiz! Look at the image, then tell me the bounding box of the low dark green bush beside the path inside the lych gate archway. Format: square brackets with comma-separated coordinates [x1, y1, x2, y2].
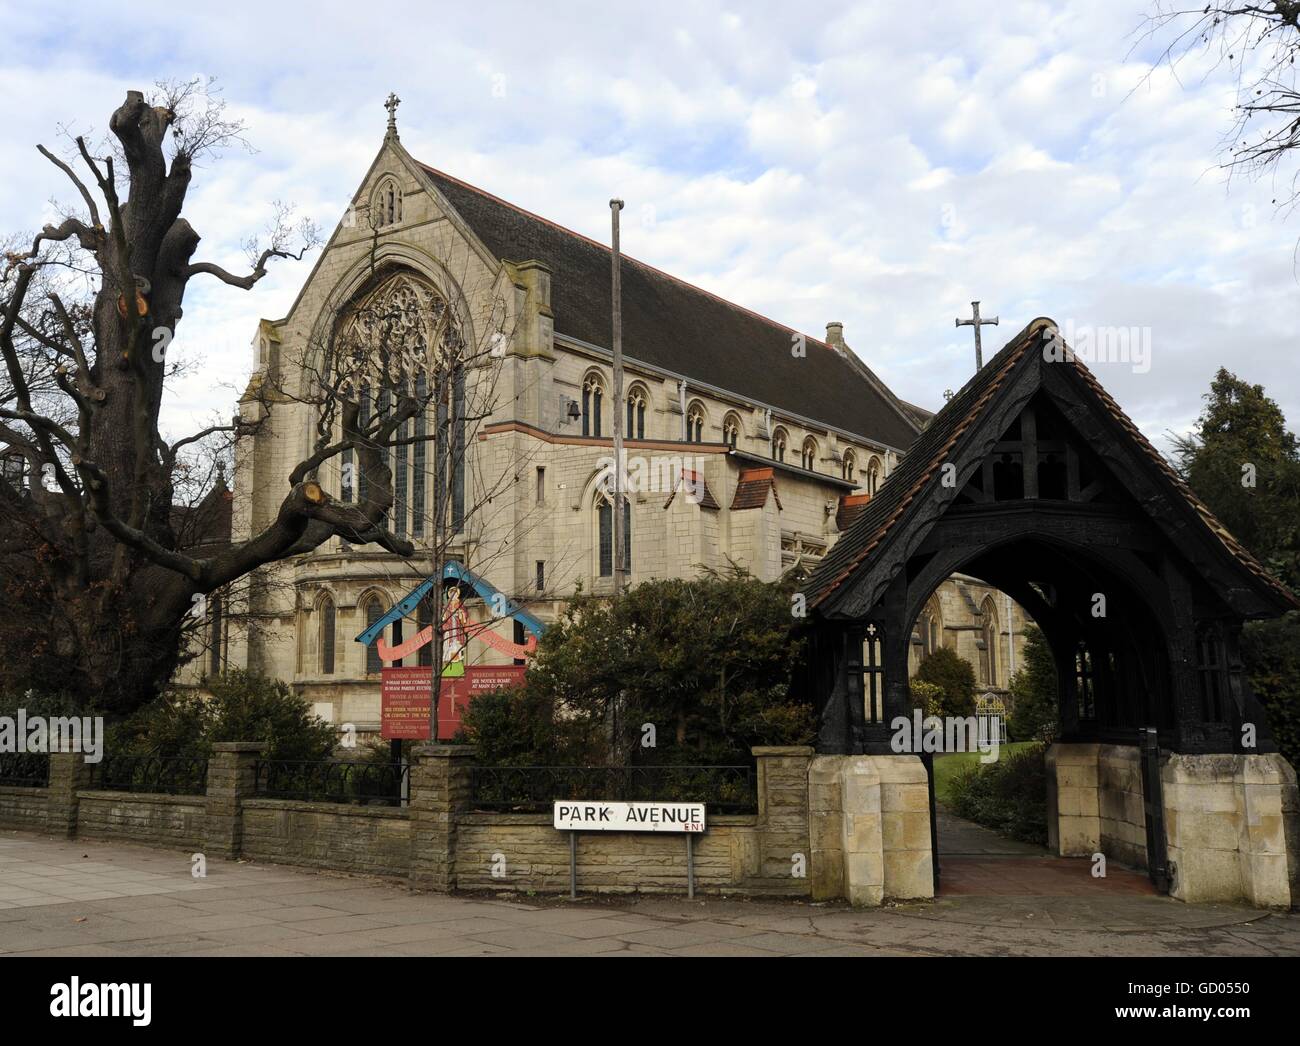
[948, 745, 1048, 845]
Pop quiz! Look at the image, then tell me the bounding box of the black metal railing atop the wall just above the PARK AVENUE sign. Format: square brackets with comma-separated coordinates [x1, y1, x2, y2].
[469, 765, 758, 813]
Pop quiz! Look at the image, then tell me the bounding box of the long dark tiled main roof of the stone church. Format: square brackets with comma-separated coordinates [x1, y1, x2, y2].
[425, 166, 917, 450]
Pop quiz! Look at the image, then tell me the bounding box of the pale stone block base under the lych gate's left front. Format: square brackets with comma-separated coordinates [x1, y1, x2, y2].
[809, 755, 935, 906]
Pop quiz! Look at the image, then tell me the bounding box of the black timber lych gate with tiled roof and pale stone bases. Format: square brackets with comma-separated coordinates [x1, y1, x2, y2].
[805, 320, 1296, 904]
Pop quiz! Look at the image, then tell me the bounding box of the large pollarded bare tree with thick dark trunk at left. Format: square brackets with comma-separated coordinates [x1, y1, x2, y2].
[0, 83, 436, 713]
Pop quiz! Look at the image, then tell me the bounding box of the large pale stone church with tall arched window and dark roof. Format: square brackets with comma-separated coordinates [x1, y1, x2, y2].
[182, 109, 1026, 732]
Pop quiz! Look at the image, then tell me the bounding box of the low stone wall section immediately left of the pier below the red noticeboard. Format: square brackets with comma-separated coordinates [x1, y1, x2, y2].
[241, 799, 411, 878]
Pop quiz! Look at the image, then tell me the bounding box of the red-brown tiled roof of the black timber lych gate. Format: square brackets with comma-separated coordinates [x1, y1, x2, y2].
[803, 317, 1300, 607]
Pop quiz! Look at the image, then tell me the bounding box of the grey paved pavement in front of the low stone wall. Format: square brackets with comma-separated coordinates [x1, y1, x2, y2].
[0, 832, 1300, 956]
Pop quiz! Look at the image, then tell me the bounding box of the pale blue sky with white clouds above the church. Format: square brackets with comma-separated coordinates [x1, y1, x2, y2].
[0, 0, 1300, 447]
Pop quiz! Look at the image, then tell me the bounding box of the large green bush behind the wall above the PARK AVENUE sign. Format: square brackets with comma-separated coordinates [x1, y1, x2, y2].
[464, 570, 816, 767]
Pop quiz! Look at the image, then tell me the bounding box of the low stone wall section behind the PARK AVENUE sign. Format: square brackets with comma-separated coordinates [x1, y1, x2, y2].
[456, 813, 759, 894]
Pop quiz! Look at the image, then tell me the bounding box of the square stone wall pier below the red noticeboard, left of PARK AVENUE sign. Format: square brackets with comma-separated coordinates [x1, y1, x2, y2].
[410, 745, 475, 893]
